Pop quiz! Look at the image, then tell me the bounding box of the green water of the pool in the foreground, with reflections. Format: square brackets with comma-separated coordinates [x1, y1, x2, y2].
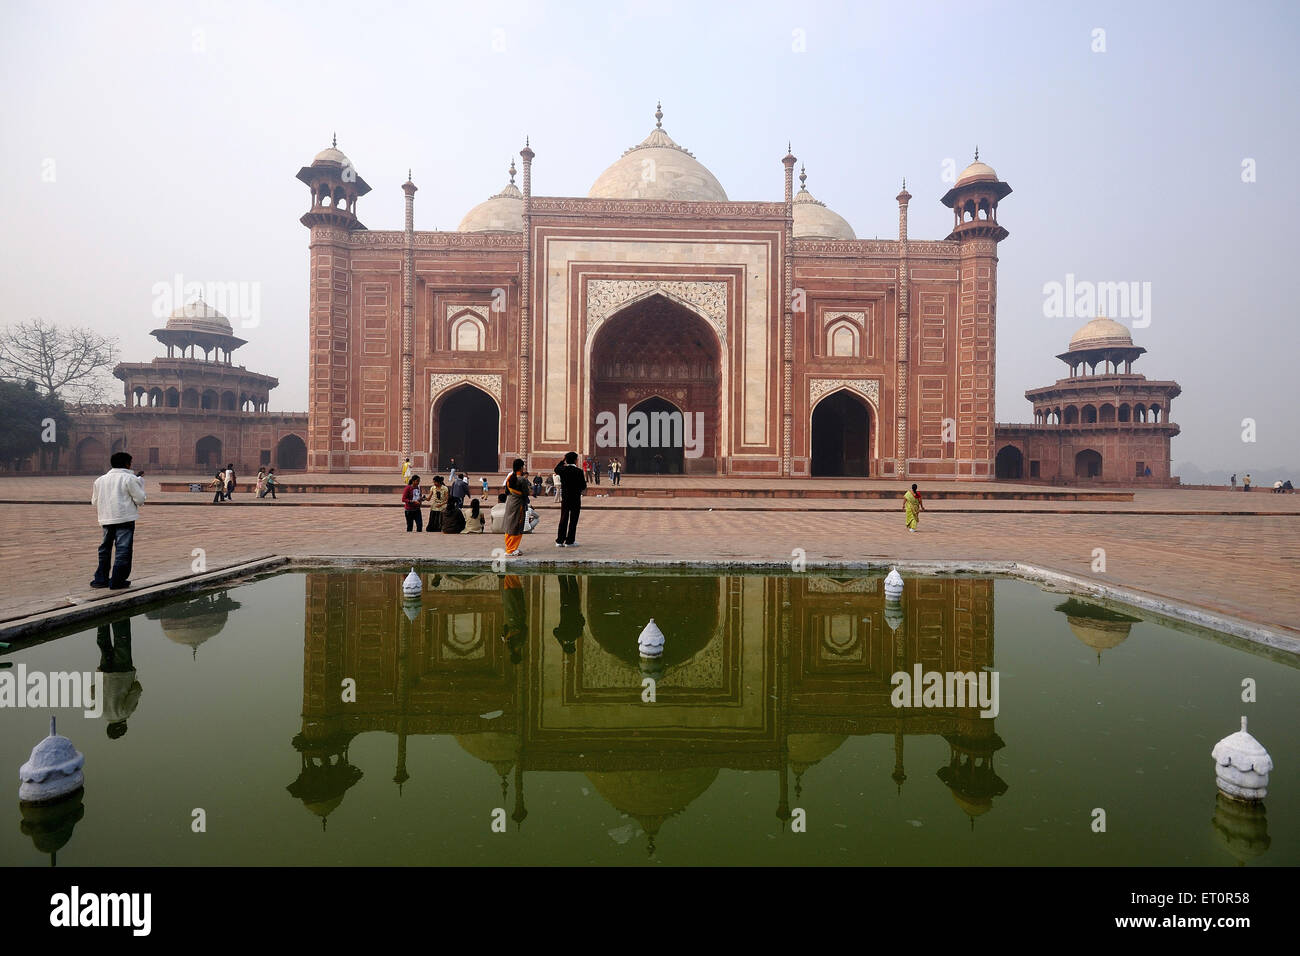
[0, 568, 1300, 866]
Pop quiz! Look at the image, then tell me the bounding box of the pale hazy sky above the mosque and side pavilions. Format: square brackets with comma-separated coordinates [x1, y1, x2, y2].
[0, 0, 1300, 471]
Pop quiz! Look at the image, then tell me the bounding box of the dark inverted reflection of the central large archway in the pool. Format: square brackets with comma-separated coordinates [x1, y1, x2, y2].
[586, 575, 720, 671]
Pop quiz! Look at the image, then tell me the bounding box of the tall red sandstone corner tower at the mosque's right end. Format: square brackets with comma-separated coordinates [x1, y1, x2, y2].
[943, 148, 1011, 480]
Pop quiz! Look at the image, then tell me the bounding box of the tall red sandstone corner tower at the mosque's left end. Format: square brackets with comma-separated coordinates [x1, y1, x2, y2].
[298, 137, 371, 471]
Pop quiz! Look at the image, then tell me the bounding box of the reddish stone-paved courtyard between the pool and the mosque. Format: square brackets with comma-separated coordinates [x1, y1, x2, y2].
[0, 477, 1300, 640]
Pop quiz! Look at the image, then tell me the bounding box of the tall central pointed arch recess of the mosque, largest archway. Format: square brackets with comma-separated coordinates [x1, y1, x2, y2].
[588, 294, 722, 475]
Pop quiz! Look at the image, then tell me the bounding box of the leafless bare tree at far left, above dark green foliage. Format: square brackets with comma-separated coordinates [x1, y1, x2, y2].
[0, 319, 117, 405]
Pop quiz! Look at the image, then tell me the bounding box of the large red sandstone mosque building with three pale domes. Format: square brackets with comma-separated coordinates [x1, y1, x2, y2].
[298, 114, 1010, 480]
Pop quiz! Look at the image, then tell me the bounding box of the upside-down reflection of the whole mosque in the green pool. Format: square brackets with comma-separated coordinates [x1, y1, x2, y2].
[290, 572, 1006, 849]
